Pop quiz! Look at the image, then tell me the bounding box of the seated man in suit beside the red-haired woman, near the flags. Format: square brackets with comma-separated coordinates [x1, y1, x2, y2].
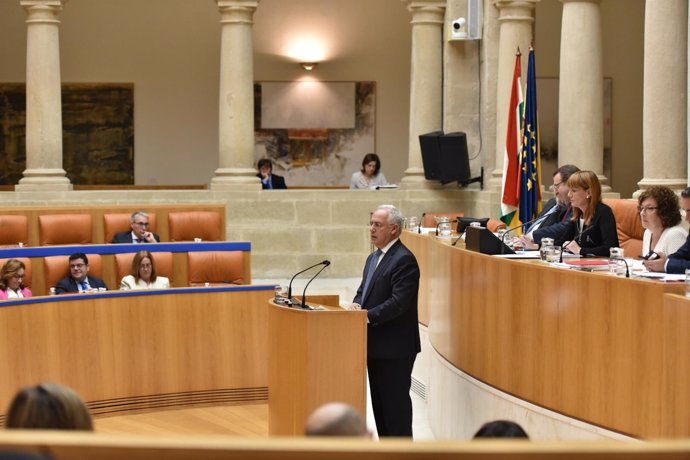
[521, 165, 580, 249]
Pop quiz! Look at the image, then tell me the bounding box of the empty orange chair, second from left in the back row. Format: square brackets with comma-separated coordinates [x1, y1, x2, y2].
[38, 214, 93, 246]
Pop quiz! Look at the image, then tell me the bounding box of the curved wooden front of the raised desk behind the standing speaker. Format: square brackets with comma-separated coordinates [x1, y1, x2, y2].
[403, 232, 690, 437]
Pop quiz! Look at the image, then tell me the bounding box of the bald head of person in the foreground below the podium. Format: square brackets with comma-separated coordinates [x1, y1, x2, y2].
[305, 402, 371, 437]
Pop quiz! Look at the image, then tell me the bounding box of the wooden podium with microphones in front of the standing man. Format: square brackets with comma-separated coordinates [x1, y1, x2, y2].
[268, 296, 367, 436]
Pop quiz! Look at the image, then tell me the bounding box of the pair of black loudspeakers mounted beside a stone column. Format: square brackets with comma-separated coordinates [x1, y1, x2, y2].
[419, 131, 471, 185]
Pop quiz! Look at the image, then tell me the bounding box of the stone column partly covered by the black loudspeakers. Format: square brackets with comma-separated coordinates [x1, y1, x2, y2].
[401, 0, 446, 189]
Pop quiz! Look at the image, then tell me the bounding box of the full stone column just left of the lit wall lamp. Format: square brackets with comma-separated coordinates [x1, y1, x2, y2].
[211, 0, 261, 190]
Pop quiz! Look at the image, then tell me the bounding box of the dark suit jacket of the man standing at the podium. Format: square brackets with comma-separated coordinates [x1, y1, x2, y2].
[354, 240, 421, 359]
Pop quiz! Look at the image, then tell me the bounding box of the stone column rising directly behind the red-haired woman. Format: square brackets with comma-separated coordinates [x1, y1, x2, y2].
[558, 0, 611, 191]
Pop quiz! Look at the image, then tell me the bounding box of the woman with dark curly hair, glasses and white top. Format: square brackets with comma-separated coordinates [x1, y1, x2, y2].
[637, 186, 688, 260]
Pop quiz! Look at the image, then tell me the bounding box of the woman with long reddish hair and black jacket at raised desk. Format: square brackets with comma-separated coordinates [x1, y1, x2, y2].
[556, 171, 618, 257]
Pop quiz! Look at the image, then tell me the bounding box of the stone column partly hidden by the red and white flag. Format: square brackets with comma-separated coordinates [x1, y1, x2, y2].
[489, 0, 539, 190]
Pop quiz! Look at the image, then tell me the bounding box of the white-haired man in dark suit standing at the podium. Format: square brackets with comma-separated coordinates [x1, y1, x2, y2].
[350, 205, 421, 437]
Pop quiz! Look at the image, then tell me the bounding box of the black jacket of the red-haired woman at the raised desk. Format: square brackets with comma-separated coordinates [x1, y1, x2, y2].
[554, 203, 619, 257]
